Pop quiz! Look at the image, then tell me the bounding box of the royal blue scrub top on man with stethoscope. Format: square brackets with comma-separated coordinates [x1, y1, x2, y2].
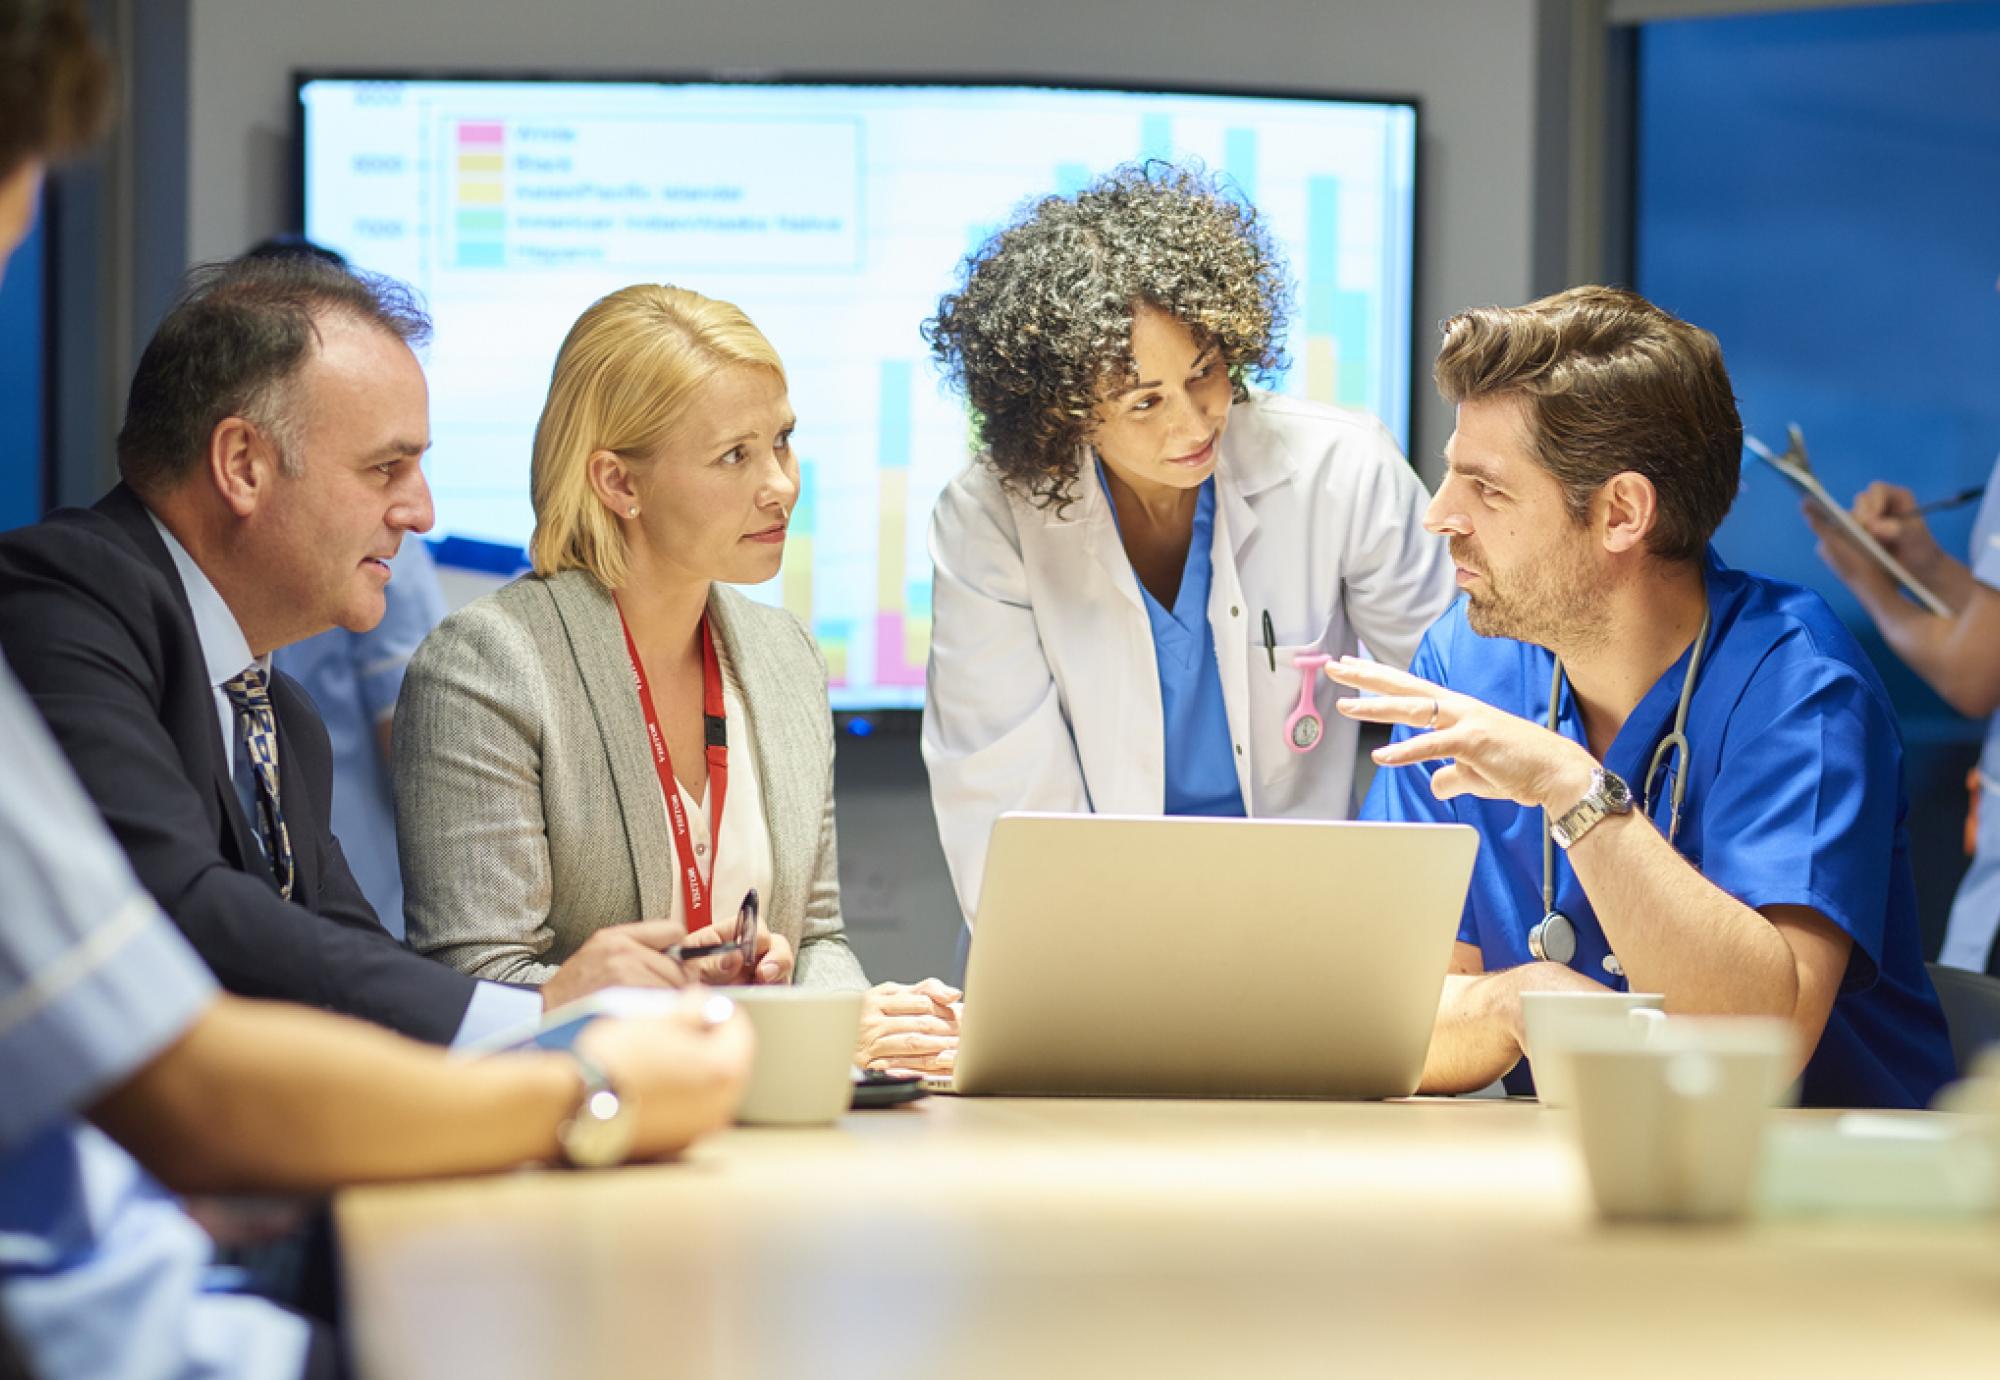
[1362, 548, 1954, 1106]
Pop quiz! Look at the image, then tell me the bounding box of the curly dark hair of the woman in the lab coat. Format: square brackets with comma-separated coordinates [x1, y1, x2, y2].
[924, 160, 1290, 508]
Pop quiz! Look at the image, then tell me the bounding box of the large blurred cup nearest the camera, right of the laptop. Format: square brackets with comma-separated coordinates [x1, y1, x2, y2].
[1568, 1016, 1796, 1222]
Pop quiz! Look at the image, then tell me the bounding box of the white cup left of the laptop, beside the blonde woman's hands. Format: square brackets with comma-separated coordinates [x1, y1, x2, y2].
[718, 986, 862, 1126]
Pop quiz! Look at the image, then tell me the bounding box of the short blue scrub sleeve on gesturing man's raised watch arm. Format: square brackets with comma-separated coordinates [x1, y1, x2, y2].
[1702, 656, 1902, 992]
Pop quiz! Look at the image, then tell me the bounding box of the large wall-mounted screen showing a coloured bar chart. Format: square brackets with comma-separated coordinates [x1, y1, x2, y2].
[298, 74, 1416, 708]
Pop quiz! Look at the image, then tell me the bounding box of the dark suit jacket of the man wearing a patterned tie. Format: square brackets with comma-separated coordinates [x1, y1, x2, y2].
[0, 484, 476, 1044]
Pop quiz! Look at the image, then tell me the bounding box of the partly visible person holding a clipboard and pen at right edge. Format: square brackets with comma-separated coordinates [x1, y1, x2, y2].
[1802, 452, 2000, 972]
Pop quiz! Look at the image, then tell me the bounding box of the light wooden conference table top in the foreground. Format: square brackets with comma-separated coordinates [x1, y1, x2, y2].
[338, 1098, 2000, 1380]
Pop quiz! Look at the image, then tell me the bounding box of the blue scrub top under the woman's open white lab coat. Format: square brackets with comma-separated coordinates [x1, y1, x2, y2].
[1098, 460, 1244, 818]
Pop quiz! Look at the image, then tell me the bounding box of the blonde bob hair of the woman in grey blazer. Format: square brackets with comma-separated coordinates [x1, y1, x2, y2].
[528, 282, 784, 590]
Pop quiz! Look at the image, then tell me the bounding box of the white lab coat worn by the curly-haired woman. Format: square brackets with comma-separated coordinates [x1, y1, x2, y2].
[924, 394, 1456, 918]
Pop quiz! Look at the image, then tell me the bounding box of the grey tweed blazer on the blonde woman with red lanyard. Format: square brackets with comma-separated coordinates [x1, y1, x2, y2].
[396, 570, 868, 988]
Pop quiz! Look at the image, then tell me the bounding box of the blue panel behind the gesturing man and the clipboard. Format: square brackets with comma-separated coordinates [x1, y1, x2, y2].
[1634, 0, 2000, 944]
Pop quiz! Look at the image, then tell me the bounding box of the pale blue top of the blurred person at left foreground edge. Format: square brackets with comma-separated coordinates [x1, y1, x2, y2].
[0, 660, 310, 1380]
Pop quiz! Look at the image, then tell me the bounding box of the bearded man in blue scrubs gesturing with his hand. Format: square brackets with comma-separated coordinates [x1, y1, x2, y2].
[1328, 288, 1952, 1106]
